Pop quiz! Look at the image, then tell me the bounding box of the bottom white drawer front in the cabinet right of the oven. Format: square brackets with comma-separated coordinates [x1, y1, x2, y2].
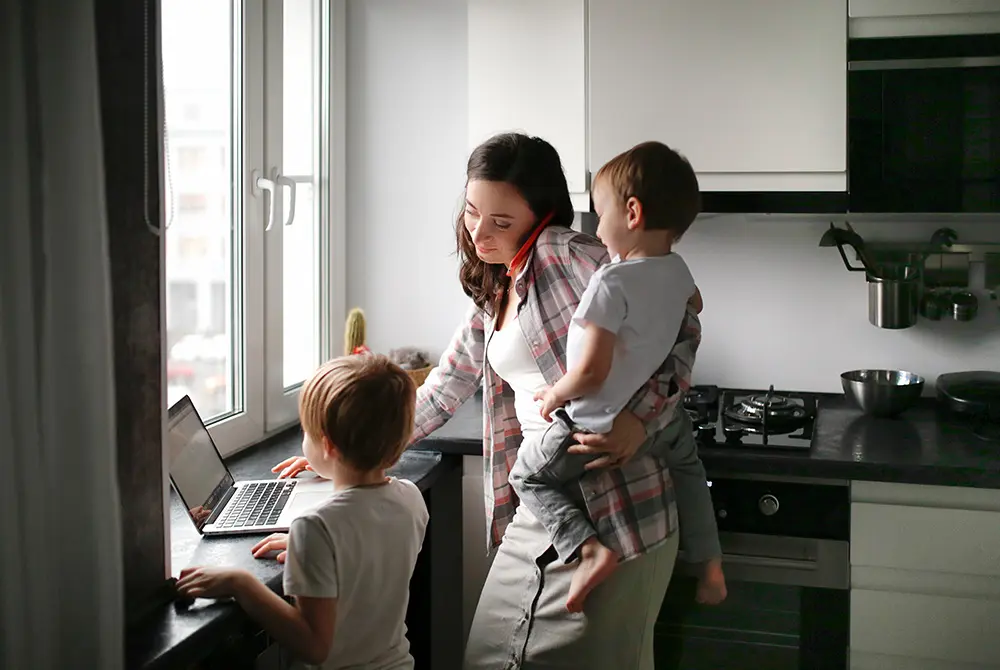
[851, 589, 1000, 668]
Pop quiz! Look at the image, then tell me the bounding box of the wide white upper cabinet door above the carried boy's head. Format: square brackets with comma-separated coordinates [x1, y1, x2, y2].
[589, 0, 847, 191]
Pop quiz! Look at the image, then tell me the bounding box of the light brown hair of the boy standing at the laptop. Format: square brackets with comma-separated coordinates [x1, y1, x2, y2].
[299, 354, 416, 472]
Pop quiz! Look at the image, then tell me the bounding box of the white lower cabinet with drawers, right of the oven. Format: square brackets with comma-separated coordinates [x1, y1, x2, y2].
[850, 482, 1000, 670]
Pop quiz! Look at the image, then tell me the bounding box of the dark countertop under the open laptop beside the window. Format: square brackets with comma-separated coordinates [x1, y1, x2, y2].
[126, 430, 460, 669]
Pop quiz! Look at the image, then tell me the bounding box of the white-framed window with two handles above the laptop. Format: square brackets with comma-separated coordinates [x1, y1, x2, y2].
[161, 0, 346, 454]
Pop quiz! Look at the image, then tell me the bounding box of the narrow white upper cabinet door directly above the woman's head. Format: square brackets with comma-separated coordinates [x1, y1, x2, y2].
[469, 0, 587, 193]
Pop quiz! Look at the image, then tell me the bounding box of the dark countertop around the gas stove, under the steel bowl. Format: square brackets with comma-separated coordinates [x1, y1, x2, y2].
[408, 395, 1000, 488]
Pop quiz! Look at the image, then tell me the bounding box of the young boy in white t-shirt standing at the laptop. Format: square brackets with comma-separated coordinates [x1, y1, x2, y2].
[177, 355, 427, 670]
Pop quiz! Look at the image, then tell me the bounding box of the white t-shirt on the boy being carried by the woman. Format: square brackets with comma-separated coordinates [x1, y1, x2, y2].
[566, 253, 695, 433]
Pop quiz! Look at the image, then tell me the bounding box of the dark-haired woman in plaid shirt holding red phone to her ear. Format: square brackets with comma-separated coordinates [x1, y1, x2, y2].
[275, 134, 700, 670]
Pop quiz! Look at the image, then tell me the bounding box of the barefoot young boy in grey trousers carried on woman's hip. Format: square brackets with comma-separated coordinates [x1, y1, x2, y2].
[510, 142, 726, 612]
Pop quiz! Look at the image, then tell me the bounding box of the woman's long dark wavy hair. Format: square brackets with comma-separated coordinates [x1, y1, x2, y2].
[455, 133, 573, 316]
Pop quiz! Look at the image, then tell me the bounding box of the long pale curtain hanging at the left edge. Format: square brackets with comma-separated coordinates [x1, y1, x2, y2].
[0, 0, 125, 670]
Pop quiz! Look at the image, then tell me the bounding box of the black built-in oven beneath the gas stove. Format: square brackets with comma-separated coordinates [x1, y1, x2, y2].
[654, 476, 850, 670]
